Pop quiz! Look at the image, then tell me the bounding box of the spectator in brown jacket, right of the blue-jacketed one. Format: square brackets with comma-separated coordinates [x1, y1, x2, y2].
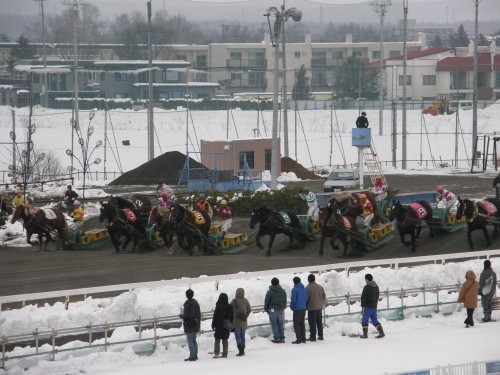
[306, 273, 326, 341]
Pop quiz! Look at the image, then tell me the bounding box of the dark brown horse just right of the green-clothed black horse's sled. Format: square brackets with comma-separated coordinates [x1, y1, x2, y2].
[318, 207, 357, 258]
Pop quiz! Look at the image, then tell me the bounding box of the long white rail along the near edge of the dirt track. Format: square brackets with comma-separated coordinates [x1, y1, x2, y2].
[0, 249, 500, 311]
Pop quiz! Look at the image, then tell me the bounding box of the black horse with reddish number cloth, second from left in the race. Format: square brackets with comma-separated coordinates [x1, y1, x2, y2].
[99, 202, 146, 253]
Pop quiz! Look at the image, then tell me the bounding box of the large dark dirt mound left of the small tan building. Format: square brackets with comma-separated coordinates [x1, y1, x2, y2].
[109, 151, 207, 186]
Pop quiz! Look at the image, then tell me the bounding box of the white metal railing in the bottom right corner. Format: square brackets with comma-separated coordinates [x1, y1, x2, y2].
[385, 359, 500, 375]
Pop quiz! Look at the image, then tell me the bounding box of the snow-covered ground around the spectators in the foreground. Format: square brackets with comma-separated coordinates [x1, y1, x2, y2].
[0, 258, 500, 375]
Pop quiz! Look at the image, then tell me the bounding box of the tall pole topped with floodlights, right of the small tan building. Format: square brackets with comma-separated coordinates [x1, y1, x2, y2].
[264, 7, 302, 190]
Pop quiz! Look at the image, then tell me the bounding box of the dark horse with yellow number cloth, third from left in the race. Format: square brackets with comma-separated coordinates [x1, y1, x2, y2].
[168, 203, 215, 255]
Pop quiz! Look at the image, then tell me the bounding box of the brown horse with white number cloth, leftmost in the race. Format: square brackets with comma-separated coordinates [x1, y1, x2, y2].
[10, 204, 68, 251]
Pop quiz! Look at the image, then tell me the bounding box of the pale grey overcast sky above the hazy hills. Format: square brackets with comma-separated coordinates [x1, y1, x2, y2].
[5, 0, 500, 24]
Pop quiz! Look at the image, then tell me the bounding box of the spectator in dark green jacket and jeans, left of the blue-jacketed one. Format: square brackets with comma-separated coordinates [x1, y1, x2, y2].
[264, 277, 286, 344]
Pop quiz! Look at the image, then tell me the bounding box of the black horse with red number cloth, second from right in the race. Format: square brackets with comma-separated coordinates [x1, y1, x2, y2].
[389, 201, 434, 252]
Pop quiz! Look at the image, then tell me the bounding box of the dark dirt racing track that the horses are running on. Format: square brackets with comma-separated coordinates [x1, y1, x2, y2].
[0, 175, 500, 296]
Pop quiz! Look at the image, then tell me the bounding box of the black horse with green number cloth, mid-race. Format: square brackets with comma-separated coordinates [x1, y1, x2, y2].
[250, 207, 307, 256]
